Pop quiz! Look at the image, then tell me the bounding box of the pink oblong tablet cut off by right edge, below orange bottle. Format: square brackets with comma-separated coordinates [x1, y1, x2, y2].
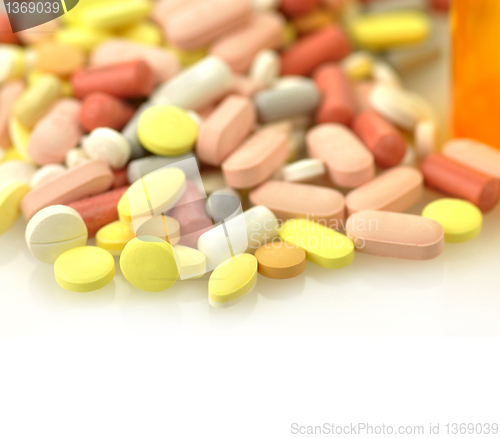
[442, 139, 500, 179]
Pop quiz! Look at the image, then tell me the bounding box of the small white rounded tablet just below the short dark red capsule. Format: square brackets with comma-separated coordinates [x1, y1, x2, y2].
[82, 128, 132, 169]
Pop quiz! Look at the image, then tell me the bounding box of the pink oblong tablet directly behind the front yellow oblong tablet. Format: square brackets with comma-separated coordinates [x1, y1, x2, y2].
[250, 181, 345, 229]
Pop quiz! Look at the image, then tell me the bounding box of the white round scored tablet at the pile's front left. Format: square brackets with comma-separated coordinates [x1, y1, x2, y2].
[26, 205, 88, 264]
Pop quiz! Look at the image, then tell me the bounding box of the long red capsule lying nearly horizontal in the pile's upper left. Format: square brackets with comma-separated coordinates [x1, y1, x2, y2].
[71, 60, 155, 99]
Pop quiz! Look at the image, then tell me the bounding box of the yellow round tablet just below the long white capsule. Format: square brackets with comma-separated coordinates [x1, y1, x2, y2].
[137, 105, 198, 157]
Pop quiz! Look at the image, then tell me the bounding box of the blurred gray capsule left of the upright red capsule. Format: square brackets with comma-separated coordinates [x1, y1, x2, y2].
[253, 78, 321, 123]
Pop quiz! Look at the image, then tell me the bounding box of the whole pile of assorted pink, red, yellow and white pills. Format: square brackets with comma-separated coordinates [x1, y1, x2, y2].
[0, 0, 492, 307]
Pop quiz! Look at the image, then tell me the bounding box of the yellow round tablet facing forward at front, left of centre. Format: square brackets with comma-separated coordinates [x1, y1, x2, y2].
[120, 236, 179, 292]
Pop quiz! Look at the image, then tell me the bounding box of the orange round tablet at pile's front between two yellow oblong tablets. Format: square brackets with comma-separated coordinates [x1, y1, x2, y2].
[255, 240, 306, 280]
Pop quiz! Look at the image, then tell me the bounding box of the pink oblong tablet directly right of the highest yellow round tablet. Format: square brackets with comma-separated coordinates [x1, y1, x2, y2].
[196, 96, 256, 167]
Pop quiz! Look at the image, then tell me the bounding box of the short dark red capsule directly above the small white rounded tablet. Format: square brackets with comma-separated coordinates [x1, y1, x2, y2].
[80, 92, 135, 132]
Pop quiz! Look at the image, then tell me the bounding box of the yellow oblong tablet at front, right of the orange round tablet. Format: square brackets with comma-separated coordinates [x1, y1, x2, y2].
[279, 219, 354, 269]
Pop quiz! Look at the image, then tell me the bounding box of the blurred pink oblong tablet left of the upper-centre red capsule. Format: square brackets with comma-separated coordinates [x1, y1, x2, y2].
[210, 12, 283, 73]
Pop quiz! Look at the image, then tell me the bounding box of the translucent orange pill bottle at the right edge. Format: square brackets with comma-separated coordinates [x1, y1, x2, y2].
[452, 0, 500, 148]
